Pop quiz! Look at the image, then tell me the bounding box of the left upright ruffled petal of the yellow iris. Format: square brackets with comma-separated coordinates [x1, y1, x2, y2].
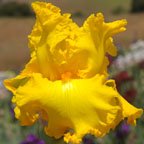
[29, 2, 82, 80]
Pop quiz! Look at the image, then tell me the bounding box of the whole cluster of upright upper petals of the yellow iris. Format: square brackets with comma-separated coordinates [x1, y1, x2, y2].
[29, 2, 126, 80]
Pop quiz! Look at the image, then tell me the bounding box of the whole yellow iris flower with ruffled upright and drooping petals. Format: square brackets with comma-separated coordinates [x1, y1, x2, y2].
[5, 2, 142, 144]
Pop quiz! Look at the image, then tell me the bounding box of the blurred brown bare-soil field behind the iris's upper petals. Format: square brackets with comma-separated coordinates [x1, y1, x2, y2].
[0, 13, 144, 71]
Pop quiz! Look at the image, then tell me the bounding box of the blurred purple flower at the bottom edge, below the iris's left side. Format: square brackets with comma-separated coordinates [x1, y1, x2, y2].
[20, 134, 45, 144]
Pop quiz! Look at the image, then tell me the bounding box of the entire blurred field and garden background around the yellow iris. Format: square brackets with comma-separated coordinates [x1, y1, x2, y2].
[0, 0, 144, 144]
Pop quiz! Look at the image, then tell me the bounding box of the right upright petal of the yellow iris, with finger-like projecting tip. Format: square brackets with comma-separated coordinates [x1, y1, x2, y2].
[83, 13, 127, 75]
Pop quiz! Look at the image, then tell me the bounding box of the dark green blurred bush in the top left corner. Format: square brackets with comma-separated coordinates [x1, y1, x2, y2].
[0, 2, 33, 17]
